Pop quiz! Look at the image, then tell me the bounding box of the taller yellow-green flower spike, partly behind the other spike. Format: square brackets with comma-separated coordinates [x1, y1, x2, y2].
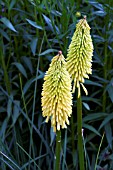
[66, 17, 93, 97]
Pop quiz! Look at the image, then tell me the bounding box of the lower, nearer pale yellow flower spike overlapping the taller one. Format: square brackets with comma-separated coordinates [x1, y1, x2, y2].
[42, 51, 72, 132]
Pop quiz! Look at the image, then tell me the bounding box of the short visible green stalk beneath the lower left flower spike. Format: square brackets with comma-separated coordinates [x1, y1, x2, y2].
[55, 130, 61, 170]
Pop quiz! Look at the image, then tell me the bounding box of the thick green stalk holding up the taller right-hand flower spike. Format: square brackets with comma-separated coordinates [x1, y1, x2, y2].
[77, 89, 85, 170]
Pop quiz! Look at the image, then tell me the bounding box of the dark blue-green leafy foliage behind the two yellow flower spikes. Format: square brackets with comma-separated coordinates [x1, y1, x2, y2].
[0, 0, 113, 170]
